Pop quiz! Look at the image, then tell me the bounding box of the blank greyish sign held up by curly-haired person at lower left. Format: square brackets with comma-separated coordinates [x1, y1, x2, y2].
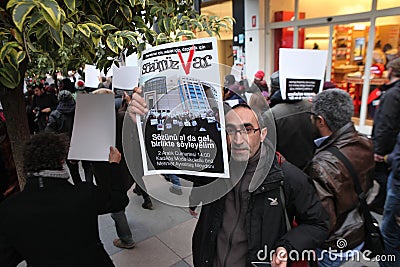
[68, 94, 115, 161]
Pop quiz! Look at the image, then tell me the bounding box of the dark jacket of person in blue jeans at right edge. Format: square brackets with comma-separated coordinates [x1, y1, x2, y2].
[372, 81, 400, 156]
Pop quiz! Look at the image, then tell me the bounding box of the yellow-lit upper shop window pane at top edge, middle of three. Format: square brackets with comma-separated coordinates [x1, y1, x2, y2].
[299, 0, 372, 19]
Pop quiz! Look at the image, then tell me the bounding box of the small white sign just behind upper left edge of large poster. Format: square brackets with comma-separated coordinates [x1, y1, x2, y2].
[112, 66, 139, 95]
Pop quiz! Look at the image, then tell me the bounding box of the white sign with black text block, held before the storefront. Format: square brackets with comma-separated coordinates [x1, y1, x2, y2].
[279, 48, 328, 100]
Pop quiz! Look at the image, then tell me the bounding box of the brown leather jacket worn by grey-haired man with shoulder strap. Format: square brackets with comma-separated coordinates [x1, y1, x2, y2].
[305, 122, 375, 249]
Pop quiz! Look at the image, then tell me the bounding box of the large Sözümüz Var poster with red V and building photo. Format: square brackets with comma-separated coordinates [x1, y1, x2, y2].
[137, 38, 229, 178]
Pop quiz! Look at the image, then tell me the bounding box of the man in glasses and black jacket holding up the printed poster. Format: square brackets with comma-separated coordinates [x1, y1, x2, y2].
[129, 90, 328, 267]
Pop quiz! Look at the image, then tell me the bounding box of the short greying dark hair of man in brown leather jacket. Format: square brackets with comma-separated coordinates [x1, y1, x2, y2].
[311, 89, 354, 132]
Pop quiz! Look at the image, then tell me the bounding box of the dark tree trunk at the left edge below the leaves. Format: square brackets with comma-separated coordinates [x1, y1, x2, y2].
[0, 62, 30, 190]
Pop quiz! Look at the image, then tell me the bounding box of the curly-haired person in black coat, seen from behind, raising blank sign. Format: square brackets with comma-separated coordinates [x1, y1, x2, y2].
[0, 133, 128, 267]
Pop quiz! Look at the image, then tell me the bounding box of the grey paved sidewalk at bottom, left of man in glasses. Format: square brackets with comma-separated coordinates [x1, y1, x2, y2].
[99, 190, 197, 267]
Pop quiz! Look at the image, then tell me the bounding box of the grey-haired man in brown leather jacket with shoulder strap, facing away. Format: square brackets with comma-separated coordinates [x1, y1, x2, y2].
[305, 89, 374, 267]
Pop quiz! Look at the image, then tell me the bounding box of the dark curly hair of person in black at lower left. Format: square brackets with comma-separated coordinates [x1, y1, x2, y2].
[23, 133, 69, 172]
